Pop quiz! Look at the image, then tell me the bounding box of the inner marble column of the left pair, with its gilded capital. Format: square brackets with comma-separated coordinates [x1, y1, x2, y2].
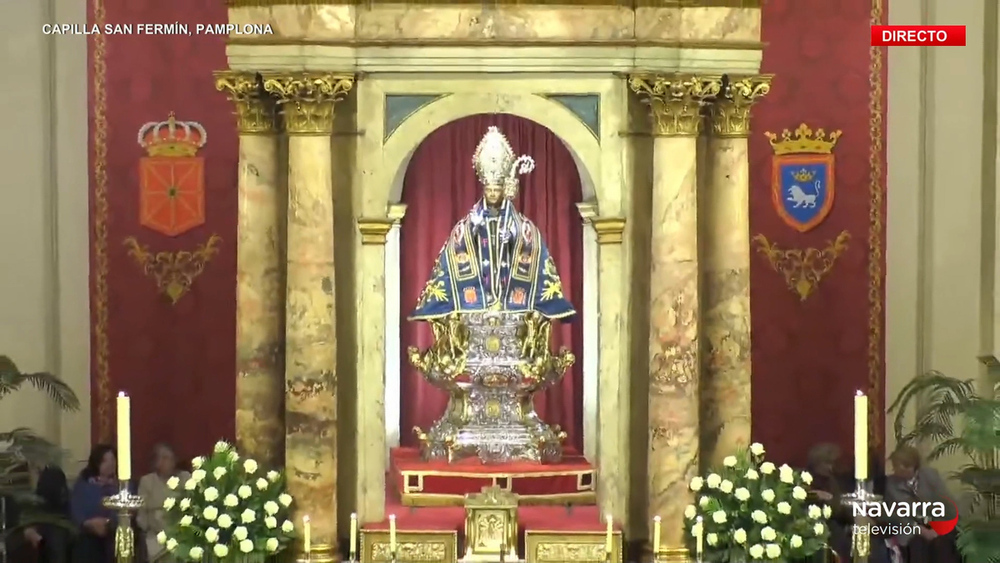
[263, 73, 354, 563]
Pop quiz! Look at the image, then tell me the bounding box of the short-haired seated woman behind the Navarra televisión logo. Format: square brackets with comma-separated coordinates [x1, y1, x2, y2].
[885, 446, 961, 563]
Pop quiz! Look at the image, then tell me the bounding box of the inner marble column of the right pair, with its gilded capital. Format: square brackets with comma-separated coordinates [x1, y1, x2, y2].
[629, 75, 721, 561]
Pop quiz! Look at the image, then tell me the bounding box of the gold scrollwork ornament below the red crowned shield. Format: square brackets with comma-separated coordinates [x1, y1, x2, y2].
[124, 235, 222, 305]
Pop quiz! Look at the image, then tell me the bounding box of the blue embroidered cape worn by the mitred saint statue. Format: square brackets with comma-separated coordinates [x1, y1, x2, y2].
[409, 201, 576, 321]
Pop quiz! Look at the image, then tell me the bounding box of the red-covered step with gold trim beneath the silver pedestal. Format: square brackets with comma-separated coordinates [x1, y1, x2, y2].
[390, 448, 596, 511]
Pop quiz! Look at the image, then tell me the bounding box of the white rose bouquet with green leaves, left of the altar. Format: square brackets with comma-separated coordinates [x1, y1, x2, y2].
[157, 442, 295, 563]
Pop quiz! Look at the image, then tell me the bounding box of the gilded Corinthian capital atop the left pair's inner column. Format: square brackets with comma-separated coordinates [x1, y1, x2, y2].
[263, 72, 354, 135]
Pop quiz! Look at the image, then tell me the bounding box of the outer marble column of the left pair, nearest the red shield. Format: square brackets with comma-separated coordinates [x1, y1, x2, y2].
[215, 71, 286, 467]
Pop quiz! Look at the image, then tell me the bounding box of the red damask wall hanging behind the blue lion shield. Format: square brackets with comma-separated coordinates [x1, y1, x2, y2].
[750, 0, 887, 468]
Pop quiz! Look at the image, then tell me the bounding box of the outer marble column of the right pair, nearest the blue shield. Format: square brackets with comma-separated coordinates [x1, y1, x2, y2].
[700, 75, 771, 470]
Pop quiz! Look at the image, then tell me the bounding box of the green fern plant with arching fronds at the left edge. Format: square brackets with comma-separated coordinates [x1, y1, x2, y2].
[0, 356, 80, 533]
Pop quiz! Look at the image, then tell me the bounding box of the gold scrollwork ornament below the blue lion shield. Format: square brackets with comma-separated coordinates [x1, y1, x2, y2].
[753, 231, 851, 301]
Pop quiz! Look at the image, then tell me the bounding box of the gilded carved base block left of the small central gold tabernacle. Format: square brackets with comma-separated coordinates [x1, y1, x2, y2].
[360, 530, 458, 563]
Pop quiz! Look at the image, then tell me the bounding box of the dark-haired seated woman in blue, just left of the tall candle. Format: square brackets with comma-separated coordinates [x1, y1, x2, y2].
[70, 444, 118, 563]
